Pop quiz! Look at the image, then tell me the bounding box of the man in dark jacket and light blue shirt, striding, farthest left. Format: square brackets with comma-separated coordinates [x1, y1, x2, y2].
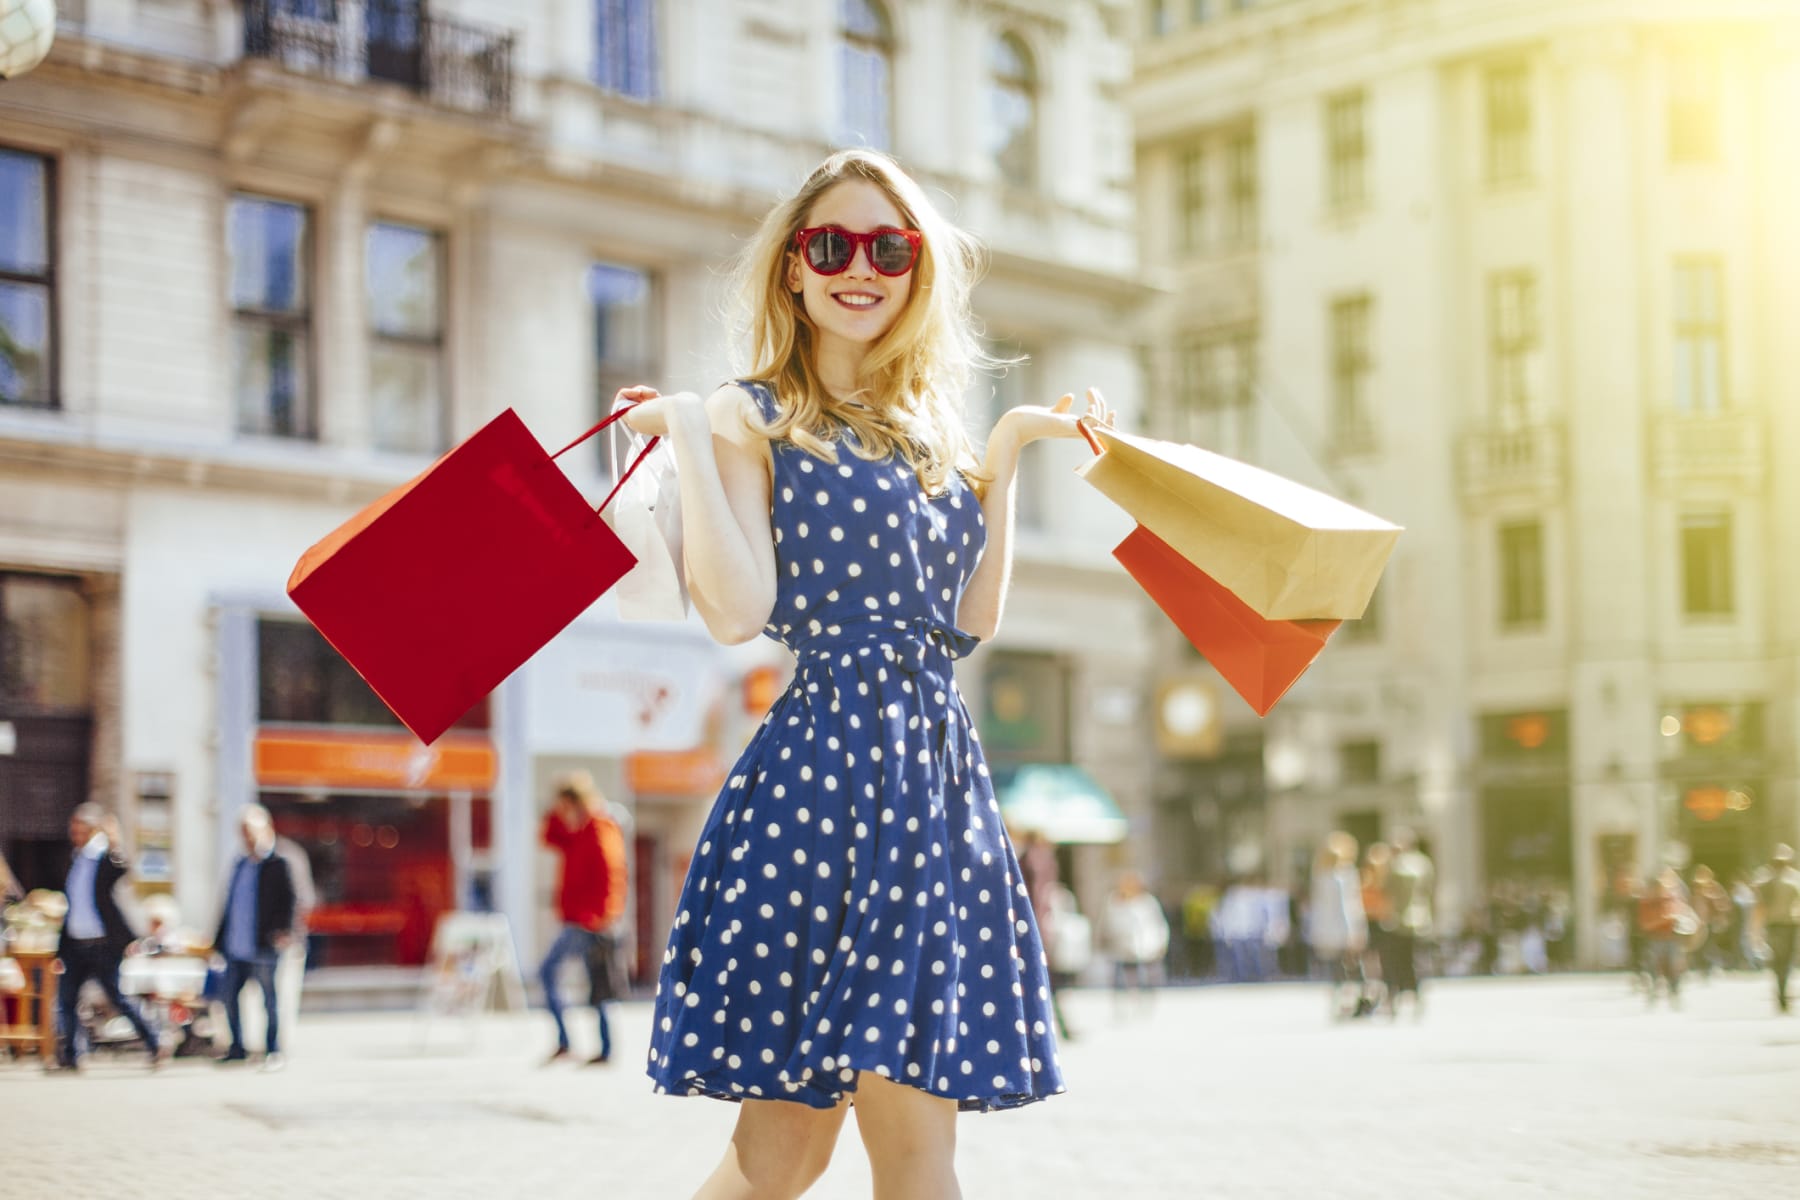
[56, 804, 160, 1070]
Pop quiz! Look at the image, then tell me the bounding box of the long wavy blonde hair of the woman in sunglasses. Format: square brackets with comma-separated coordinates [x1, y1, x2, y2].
[733, 149, 995, 493]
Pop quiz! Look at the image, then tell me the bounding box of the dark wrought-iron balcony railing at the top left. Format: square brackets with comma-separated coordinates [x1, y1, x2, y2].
[243, 0, 515, 117]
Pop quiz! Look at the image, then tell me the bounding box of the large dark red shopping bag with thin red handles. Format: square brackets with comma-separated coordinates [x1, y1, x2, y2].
[288, 408, 655, 743]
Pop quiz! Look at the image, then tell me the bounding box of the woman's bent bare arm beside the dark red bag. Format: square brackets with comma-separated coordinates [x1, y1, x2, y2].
[621, 385, 776, 644]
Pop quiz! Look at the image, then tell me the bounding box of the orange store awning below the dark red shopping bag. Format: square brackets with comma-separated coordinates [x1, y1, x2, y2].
[254, 729, 495, 792]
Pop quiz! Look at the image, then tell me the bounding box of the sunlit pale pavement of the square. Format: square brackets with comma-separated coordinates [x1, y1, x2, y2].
[0, 977, 1800, 1200]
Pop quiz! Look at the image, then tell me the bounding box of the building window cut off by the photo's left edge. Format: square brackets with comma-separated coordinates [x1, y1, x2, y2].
[0, 149, 56, 408]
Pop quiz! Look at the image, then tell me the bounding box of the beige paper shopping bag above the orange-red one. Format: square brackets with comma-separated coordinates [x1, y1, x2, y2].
[1078, 421, 1400, 621]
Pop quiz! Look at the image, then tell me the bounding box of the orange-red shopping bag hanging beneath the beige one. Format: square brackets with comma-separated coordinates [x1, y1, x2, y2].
[1112, 525, 1343, 716]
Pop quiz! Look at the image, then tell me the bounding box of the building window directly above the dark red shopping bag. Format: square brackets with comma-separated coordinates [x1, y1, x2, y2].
[365, 221, 448, 453]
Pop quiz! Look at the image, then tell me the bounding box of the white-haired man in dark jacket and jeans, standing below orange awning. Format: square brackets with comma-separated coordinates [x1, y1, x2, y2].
[212, 804, 293, 1070]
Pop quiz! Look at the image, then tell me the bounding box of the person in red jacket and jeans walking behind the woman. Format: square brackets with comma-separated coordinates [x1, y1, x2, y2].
[538, 772, 625, 1063]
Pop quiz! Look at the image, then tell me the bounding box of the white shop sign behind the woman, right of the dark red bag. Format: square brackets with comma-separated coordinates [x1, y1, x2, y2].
[526, 624, 725, 756]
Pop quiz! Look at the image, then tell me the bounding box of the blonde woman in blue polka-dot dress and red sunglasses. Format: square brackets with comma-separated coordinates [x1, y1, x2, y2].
[621, 151, 1109, 1200]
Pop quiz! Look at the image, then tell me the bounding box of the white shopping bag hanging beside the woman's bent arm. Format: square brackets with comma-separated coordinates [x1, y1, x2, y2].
[607, 408, 688, 621]
